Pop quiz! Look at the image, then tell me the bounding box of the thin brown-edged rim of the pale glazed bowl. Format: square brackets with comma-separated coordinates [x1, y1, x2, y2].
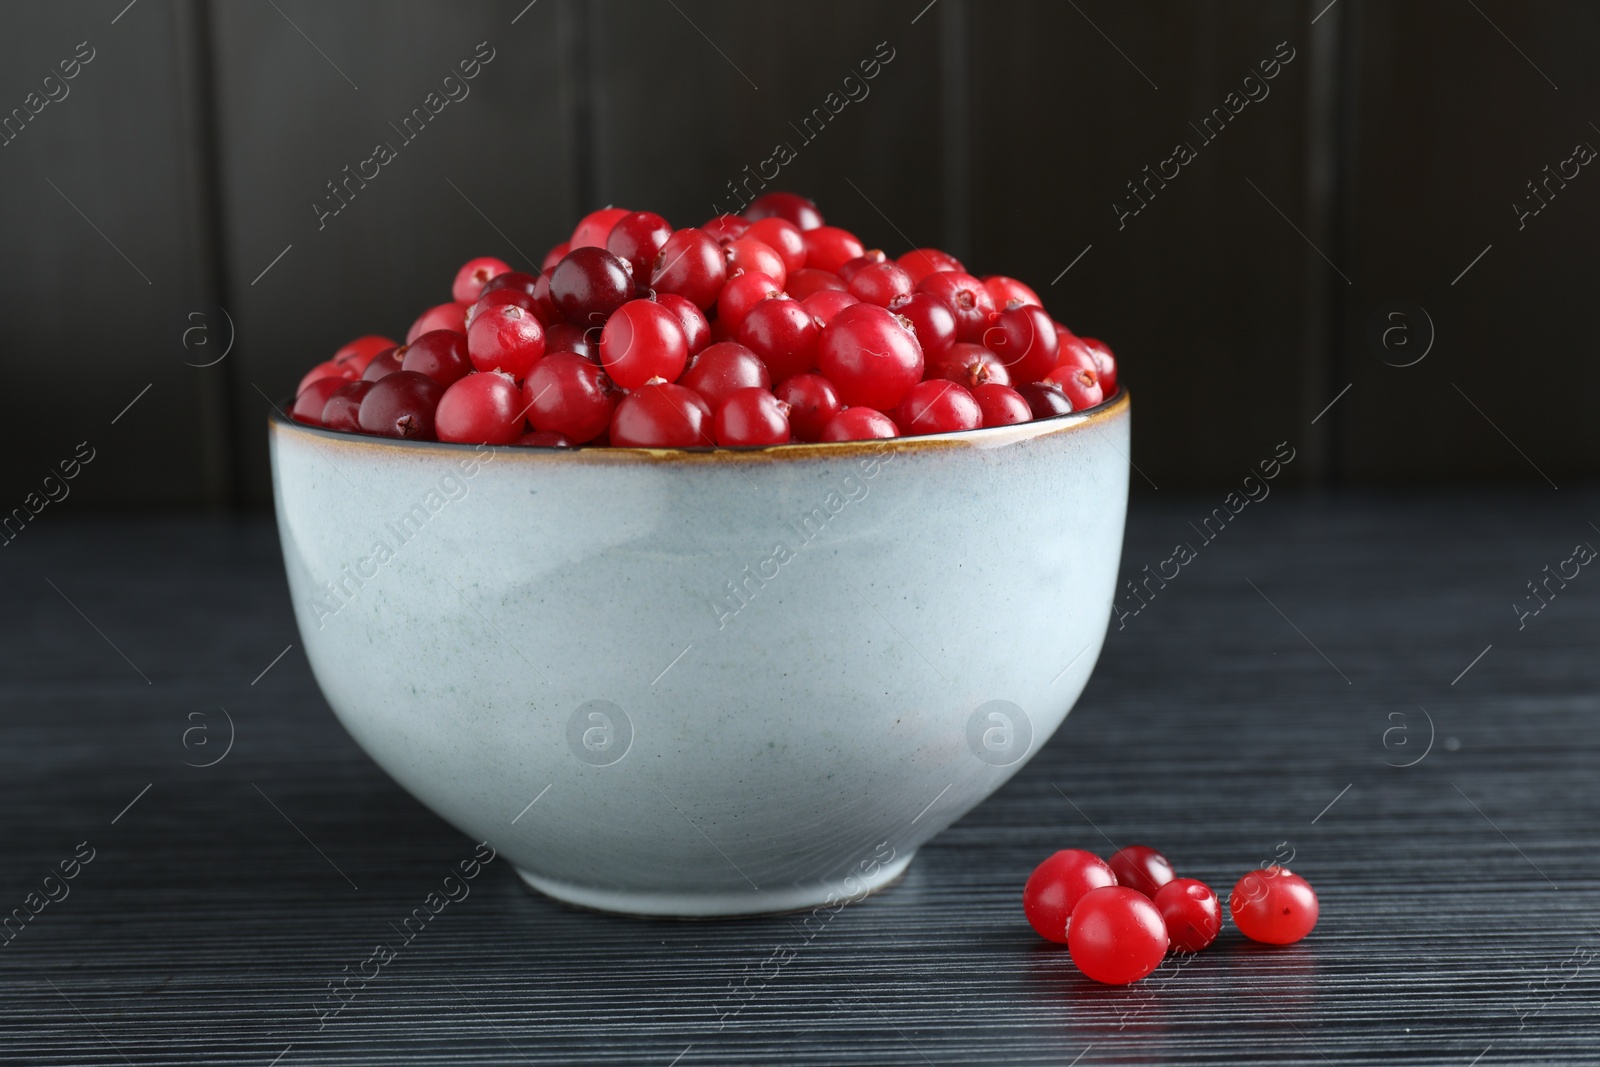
[267, 386, 1131, 464]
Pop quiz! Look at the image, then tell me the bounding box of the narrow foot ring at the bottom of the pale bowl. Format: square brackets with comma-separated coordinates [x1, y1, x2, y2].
[517, 851, 917, 918]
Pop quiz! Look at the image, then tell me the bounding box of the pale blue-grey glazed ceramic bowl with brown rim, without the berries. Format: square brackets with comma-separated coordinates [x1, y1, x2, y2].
[270, 392, 1130, 917]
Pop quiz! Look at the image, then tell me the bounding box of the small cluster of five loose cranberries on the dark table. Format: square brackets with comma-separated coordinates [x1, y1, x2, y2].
[1022, 845, 1317, 985]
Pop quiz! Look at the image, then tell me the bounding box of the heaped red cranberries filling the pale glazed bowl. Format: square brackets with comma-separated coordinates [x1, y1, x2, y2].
[293, 192, 1117, 448]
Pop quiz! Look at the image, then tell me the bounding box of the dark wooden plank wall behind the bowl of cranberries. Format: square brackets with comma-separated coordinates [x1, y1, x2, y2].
[0, 0, 1600, 512]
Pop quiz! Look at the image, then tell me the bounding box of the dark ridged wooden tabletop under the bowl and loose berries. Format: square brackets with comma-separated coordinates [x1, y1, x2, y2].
[0, 486, 1600, 1067]
